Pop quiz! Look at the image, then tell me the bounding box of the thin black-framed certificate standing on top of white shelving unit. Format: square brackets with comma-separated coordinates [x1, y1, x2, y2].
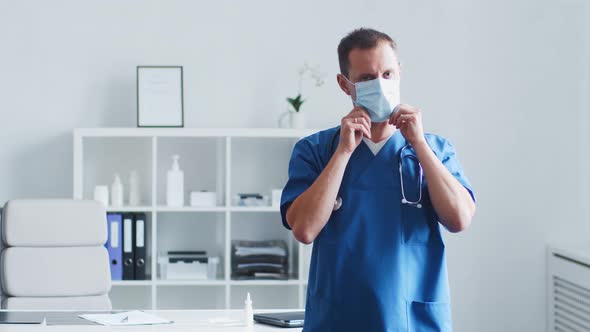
[137, 66, 184, 127]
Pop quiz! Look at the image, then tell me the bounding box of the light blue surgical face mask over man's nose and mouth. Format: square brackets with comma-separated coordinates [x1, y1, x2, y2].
[347, 77, 400, 122]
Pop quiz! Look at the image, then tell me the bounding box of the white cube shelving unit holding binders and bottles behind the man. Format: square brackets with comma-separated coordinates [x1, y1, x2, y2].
[73, 128, 317, 309]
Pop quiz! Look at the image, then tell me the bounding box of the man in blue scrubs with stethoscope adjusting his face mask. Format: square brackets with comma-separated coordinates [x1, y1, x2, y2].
[281, 29, 475, 332]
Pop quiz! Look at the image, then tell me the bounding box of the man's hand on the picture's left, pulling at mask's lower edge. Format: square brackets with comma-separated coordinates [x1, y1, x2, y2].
[338, 106, 371, 154]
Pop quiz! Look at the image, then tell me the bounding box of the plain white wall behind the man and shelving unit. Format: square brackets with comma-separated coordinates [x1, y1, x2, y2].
[0, 0, 590, 331]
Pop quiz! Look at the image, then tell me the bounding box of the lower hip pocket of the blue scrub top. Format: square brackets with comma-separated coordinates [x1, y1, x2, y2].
[407, 301, 453, 332]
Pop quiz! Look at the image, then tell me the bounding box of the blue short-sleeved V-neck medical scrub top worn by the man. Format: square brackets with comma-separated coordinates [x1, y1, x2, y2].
[281, 127, 475, 332]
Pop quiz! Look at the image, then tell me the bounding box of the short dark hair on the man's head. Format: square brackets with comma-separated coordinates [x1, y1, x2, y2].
[338, 28, 397, 77]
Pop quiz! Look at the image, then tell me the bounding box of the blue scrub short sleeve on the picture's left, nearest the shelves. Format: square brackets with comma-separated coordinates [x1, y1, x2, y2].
[281, 138, 321, 229]
